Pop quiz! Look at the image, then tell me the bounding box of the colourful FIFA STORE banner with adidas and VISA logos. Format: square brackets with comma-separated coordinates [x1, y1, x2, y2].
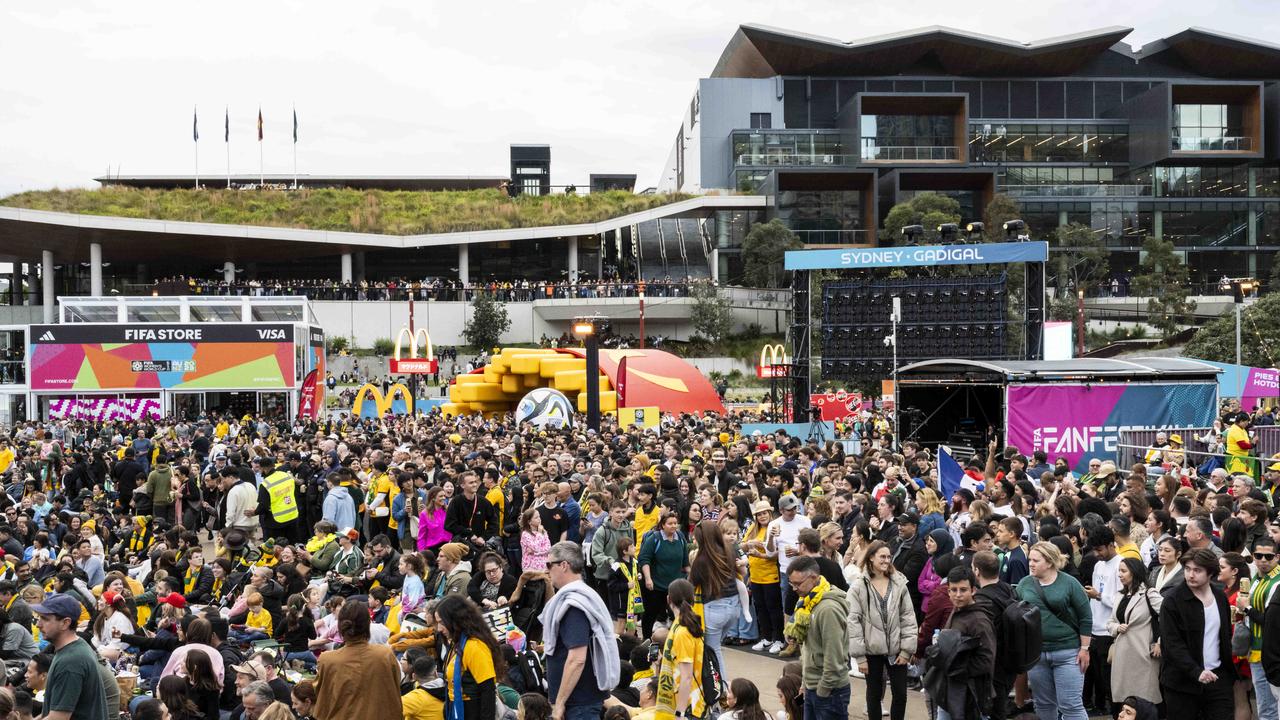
[28, 323, 294, 391]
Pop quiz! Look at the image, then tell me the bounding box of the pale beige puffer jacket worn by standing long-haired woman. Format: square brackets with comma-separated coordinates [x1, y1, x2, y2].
[845, 573, 918, 664]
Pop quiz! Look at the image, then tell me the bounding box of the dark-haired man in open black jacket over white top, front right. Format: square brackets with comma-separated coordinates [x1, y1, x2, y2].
[1160, 548, 1235, 720]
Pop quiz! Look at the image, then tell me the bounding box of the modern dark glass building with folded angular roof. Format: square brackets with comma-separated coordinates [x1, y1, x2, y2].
[658, 24, 1280, 283]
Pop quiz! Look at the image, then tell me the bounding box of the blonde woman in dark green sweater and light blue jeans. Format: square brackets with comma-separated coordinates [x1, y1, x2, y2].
[1016, 542, 1093, 720]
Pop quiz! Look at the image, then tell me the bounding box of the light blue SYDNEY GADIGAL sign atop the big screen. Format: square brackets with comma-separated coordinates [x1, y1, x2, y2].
[786, 242, 1048, 270]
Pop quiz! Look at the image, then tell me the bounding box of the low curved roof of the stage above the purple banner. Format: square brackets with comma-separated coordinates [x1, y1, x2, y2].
[897, 357, 1221, 383]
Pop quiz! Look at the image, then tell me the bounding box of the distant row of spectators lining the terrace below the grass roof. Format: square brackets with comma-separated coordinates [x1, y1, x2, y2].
[154, 275, 709, 302]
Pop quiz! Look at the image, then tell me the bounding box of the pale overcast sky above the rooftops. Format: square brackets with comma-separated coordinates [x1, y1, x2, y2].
[0, 0, 1280, 196]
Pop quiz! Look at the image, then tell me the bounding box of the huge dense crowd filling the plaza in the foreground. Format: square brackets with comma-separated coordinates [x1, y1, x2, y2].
[0, 399, 1280, 720]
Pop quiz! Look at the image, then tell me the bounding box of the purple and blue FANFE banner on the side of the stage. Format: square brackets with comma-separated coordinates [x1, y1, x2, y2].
[1005, 383, 1217, 473]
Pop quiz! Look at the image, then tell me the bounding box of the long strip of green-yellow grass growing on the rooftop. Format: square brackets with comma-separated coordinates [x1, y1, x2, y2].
[0, 187, 691, 234]
